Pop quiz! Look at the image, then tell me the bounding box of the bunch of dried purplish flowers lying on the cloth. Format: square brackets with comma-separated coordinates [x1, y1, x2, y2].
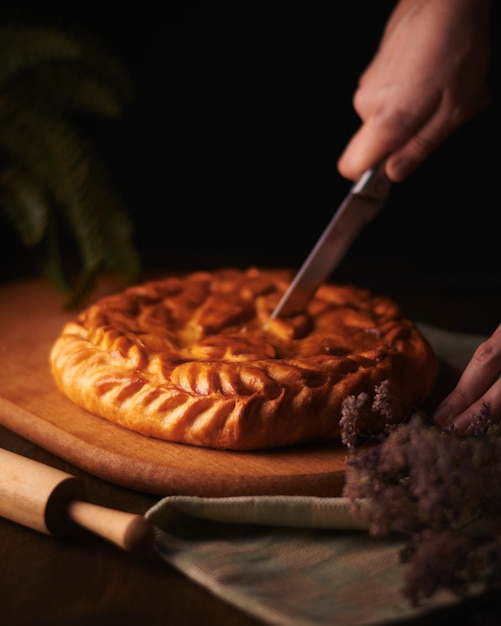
[341, 381, 501, 604]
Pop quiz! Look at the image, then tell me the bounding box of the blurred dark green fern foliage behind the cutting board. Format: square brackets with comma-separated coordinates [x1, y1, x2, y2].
[0, 22, 139, 306]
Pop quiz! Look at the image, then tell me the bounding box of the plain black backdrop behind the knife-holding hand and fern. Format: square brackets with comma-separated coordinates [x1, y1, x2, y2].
[0, 0, 501, 289]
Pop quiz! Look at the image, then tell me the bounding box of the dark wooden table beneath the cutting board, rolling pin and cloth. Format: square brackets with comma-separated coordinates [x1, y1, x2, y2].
[0, 272, 501, 626]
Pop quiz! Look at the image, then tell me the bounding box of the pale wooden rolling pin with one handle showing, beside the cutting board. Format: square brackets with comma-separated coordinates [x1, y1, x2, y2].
[0, 449, 153, 552]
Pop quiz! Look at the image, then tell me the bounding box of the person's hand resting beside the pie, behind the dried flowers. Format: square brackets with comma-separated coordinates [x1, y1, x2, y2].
[433, 324, 501, 435]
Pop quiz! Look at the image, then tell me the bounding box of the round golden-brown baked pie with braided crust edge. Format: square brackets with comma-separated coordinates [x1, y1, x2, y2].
[50, 268, 437, 450]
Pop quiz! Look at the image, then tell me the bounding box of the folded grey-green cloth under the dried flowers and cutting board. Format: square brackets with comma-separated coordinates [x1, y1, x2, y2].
[146, 324, 484, 626]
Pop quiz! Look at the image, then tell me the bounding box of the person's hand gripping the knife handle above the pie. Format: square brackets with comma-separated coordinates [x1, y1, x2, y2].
[337, 0, 490, 182]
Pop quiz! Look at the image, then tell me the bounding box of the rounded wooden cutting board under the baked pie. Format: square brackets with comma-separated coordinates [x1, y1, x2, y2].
[0, 279, 346, 497]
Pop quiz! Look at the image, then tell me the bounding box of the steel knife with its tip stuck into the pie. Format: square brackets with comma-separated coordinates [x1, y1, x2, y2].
[271, 161, 391, 318]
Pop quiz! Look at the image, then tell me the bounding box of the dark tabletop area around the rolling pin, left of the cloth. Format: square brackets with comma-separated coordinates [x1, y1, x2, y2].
[0, 425, 266, 626]
